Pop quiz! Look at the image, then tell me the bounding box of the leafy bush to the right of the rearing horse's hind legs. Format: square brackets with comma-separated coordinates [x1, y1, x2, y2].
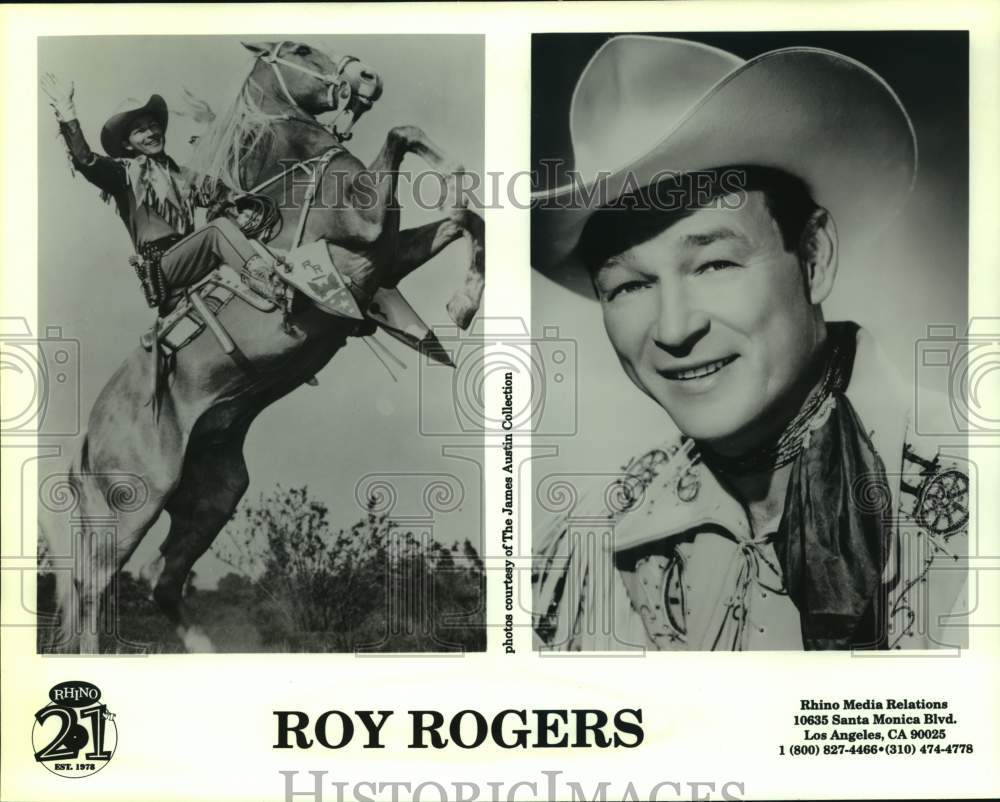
[213, 487, 486, 651]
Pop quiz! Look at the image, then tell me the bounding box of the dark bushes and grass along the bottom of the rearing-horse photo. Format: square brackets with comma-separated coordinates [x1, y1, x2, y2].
[37, 487, 486, 653]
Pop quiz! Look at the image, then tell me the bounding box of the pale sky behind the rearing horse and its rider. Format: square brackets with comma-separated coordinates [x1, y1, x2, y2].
[38, 32, 484, 587]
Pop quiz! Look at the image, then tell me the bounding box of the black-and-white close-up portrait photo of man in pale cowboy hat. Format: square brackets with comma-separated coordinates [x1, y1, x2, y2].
[531, 31, 972, 651]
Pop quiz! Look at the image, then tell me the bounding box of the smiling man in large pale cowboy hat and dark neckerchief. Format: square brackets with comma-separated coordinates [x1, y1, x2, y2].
[532, 35, 968, 650]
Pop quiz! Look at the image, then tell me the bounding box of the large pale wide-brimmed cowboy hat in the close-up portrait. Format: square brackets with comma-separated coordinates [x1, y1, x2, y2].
[531, 35, 917, 297]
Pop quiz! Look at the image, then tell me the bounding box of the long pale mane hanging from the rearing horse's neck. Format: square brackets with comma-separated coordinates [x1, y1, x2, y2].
[188, 60, 281, 194]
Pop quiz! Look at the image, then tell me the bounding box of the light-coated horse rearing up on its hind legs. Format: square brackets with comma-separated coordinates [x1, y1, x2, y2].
[39, 42, 484, 652]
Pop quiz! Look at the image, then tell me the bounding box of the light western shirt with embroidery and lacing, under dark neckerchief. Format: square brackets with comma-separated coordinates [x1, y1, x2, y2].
[533, 329, 969, 651]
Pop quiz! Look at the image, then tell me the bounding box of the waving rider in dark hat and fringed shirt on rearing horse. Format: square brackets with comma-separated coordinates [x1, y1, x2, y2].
[42, 74, 271, 307]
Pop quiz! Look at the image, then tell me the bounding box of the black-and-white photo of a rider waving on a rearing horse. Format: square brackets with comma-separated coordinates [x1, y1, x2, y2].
[31, 33, 485, 653]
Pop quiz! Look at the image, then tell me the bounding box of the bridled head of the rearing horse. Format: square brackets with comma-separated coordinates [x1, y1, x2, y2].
[243, 41, 382, 139]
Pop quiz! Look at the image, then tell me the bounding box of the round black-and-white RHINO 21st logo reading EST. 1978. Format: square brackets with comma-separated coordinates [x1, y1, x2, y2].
[31, 681, 118, 777]
